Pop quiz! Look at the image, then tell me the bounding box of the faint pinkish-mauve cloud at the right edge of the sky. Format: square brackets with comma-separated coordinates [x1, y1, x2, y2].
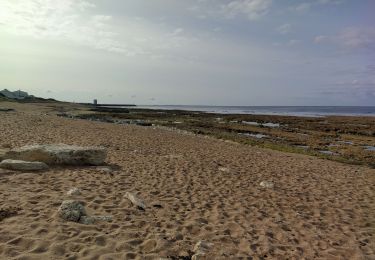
[314, 27, 375, 50]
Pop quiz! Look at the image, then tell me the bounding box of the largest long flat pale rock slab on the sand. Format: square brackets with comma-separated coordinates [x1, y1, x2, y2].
[5, 144, 107, 165]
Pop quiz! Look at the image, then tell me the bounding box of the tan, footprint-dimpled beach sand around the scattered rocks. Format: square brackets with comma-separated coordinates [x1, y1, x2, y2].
[0, 105, 375, 259]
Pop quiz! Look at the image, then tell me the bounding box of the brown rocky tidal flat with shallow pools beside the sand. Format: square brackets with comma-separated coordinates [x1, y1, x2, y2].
[77, 102, 375, 167]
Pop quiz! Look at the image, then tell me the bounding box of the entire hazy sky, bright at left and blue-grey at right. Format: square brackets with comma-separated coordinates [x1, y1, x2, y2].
[0, 0, 375, 106]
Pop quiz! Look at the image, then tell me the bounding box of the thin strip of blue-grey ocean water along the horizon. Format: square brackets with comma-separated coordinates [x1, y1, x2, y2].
[133, 106, 375, 117]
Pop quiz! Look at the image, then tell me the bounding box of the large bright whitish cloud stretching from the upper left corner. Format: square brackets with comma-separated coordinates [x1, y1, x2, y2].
[0, 0, 197, 57]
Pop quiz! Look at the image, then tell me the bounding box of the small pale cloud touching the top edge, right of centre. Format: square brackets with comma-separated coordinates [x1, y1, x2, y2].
[221, 0, 272, 20]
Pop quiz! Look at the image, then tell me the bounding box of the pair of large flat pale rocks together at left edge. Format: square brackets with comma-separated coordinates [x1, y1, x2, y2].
[0, 144, 107, 171]
